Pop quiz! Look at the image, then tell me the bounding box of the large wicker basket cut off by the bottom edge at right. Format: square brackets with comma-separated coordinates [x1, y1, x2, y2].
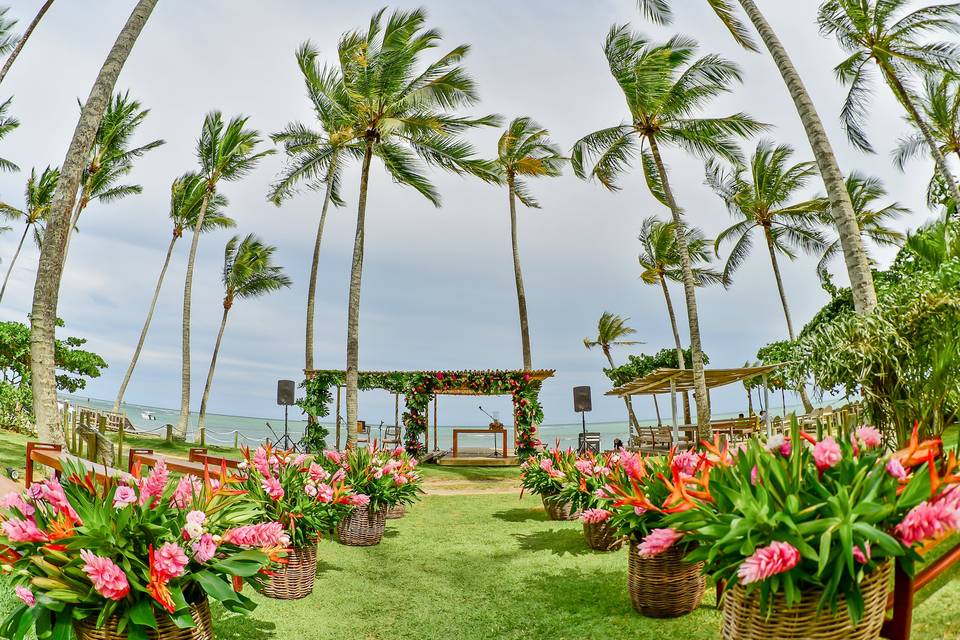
[722, 561, 890, 640]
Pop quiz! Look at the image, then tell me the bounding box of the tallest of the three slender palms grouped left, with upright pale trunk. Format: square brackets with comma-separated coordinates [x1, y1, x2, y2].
[176, 111, 273, 439]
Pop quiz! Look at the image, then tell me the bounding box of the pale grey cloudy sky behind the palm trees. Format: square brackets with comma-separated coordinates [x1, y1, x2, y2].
[0, 0, 944, 424]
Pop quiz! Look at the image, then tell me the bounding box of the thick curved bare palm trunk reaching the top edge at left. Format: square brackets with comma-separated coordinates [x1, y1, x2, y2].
[30, 0, 157, 444]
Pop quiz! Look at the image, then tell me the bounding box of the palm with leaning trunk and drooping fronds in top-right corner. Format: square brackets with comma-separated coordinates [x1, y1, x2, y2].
[818, 0, 960, 209]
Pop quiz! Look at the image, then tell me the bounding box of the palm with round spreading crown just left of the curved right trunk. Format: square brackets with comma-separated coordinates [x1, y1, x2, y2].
[707, 140, 829, 340]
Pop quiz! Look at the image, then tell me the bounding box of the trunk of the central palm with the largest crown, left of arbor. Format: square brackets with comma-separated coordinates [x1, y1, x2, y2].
[345, 136, 374, 448]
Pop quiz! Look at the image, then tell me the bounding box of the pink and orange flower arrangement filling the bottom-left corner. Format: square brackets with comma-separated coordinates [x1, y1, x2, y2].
[0, 460, 289, 640]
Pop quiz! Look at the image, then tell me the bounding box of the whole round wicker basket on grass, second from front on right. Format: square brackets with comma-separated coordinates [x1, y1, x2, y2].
[627, 542, 708, 616]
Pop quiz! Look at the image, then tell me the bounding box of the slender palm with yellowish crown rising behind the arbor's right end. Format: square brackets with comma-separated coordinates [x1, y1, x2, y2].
[494, 117, 566, 370]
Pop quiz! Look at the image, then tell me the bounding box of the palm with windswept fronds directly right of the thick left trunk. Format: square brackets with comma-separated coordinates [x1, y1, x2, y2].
[64, 91, 164, 260]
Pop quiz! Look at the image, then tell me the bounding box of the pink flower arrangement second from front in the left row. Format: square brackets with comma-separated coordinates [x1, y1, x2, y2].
[240, 445, 351, 548]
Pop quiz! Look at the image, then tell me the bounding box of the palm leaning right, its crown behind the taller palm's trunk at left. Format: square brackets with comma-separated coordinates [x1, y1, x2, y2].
[113, 172, 236, 412]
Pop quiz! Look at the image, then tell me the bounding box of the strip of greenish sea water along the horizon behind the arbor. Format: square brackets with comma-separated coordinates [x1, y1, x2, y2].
[60, 394, 801, 449]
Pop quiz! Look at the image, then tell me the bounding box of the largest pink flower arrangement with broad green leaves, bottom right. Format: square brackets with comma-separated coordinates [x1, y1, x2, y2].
[668, 421, 960, 625]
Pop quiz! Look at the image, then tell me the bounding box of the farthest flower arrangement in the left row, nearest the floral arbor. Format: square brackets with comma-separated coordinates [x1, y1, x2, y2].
[317, 446, 423, 511]
